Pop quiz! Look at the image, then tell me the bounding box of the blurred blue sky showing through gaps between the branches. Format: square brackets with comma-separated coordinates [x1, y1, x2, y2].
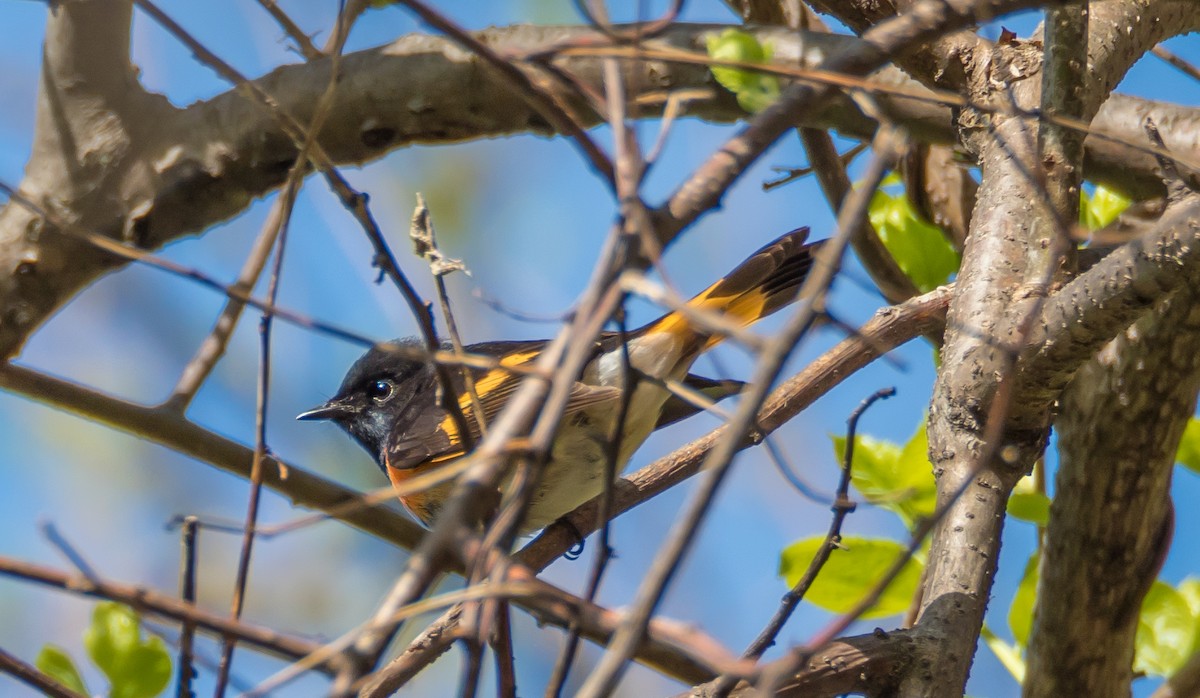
[0, 0, 1200, 697]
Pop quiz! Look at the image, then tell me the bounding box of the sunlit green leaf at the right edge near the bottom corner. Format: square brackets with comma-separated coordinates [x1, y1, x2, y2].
[1133, 582, 1196, 676]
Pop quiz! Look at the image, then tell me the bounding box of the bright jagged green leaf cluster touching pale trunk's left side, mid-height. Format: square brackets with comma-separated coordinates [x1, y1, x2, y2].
[833, 423, 937, 529]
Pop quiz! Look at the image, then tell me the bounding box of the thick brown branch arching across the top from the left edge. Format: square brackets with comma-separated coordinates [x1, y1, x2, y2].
[0, 19, 1200, 355]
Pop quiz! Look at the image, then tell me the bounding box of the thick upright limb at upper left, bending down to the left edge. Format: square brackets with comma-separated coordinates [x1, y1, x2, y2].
[0, 0, 174, 357]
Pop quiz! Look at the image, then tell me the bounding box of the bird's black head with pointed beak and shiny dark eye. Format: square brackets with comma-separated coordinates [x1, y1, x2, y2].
[296, 338, 436, 467]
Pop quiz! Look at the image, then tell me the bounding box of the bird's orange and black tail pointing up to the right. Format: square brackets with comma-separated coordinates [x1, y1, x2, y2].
[643, 228, 824, 351]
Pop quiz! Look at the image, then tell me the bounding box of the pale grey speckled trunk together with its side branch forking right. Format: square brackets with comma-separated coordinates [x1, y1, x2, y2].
[904, 2, 1196, 694]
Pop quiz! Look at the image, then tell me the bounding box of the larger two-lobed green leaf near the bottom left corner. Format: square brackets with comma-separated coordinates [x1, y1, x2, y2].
[83, 602, 170, 698]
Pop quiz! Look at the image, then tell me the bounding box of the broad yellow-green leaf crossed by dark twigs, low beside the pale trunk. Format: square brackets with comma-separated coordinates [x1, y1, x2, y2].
[779, 536, 922, 618]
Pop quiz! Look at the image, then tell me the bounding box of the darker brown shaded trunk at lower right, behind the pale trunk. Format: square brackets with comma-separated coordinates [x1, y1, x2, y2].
[1025, 288, 1200, 698]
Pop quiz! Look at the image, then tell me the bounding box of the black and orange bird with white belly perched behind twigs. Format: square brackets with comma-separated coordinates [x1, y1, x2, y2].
[296, 228, 821, 532]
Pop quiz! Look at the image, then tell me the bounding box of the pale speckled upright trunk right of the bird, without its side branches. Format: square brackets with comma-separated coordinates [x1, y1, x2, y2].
[904, 28, 1066, 696]
